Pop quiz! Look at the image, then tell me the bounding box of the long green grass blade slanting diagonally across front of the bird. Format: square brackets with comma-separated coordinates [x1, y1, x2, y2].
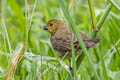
[59, 0, 99, 80]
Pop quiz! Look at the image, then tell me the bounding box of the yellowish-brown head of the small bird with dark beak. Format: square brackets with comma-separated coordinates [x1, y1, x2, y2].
[43, 19, 64, 35]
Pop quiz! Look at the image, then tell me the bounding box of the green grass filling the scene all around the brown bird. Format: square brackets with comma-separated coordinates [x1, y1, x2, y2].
[0, 0, 120, 80]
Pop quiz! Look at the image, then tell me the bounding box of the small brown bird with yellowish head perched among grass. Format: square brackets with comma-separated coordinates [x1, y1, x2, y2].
[43, 19, 101, 59]
